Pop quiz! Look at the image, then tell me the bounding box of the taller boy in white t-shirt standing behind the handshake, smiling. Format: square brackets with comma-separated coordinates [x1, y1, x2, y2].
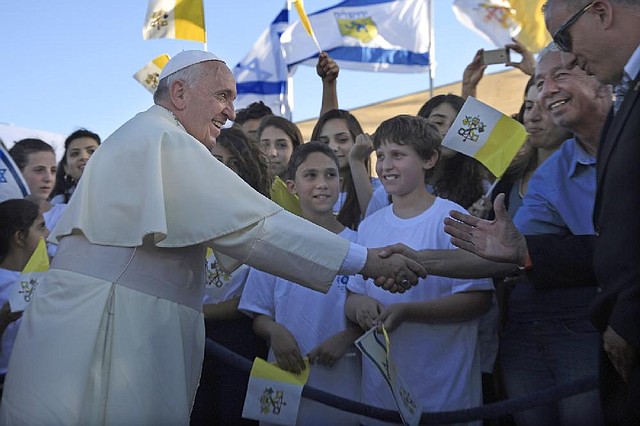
[345, 115, 493, 424]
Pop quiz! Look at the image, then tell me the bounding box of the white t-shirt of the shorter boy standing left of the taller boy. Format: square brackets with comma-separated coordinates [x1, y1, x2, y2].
[238, 228, 360, 426]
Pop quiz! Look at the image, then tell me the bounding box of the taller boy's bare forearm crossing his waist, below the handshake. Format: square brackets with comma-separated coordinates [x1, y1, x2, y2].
[378, 291, 493, 331]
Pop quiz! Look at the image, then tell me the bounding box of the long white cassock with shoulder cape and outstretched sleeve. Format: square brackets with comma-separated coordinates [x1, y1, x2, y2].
[0, 106, 364, 426]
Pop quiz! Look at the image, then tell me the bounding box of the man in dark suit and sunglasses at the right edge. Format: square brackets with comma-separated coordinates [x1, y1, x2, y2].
[545, 0, 640, 424]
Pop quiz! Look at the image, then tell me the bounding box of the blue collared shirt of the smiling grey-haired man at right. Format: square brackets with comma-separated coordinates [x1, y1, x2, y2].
[514, 138, 596, 235]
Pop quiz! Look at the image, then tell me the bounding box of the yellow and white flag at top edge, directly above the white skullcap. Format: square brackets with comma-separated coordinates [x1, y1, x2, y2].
[142, 0, 207, 43]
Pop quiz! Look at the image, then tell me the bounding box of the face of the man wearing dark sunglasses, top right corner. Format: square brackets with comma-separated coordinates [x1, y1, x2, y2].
[545, 0, 621, 84]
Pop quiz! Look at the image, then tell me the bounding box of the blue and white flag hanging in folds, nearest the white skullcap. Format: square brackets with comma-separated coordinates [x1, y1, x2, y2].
[233, 2, 292, 119]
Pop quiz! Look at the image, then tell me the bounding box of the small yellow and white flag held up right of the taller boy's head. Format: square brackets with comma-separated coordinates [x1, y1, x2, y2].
[442, 96, 527, 177]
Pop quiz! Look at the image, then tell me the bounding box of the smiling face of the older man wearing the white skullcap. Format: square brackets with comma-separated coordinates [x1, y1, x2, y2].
[180, 61, 236, 149]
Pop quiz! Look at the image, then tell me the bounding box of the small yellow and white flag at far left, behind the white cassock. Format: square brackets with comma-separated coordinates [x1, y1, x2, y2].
[9, 238, 49, 312]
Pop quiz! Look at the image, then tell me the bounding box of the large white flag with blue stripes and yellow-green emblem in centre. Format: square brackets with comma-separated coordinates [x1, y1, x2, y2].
[280, 0, 433, 73]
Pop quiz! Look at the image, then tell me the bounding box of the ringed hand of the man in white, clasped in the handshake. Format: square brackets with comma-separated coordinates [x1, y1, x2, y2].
[360, 248, 427, 293]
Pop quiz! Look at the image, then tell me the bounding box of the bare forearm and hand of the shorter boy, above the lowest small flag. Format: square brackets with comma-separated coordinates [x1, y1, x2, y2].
[253, 315, 306, 373]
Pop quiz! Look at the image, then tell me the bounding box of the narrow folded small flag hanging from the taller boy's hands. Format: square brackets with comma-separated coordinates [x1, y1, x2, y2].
[355, 327, 422, 426]
